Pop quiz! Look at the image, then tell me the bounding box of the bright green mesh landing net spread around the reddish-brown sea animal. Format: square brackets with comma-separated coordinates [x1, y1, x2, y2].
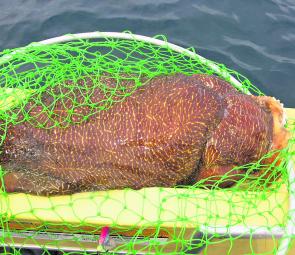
[0, 33, 295, 254]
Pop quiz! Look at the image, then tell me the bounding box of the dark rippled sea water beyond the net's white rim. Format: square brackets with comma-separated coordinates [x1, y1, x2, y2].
[0, 0, 295, 107]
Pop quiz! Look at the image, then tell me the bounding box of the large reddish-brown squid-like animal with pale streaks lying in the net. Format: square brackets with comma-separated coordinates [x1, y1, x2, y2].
[0, 74, 288, 195]
